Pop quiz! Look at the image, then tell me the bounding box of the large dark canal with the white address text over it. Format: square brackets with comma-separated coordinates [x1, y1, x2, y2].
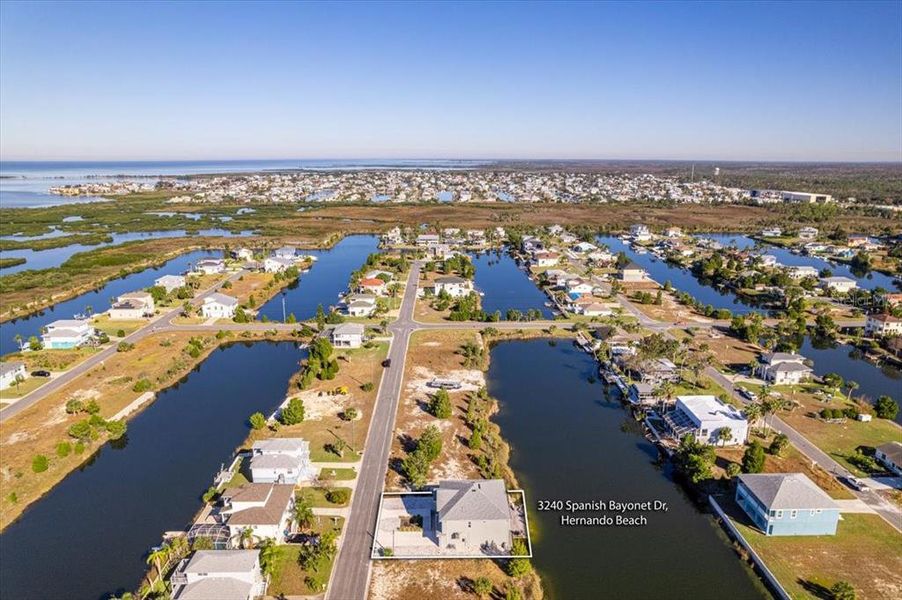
[488, 340, 768, 600]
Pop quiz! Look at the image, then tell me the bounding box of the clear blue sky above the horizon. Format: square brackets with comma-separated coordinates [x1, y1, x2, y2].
[0, 2, 902, 161]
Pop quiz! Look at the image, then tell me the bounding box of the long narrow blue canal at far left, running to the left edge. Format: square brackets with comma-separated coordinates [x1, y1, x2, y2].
[0, 250, 222, 355]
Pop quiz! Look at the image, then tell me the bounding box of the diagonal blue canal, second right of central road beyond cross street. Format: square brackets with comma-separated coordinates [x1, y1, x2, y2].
[597, 236, 766, 314]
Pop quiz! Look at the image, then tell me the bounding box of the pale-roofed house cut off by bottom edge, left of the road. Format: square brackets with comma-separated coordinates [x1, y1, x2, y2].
[170, 550, 266, 600]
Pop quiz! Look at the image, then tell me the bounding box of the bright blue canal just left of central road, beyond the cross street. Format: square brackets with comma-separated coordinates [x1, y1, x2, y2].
[258, 235, 379, 321]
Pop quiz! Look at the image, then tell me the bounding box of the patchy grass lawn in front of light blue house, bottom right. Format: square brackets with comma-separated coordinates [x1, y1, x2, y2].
[733, 509, 902, 598]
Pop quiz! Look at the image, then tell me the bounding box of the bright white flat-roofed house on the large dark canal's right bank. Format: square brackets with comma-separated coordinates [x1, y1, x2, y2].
[664, 395, 748, 446]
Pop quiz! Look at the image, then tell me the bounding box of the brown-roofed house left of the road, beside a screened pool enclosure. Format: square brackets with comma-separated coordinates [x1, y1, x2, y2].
[219, 483, 294, 544]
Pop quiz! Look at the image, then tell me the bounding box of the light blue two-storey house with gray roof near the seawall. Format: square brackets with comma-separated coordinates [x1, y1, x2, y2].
[736, 473, 839, 535]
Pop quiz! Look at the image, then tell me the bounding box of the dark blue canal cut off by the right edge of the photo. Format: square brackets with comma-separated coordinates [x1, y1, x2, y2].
[801, 338, 902, 425]
